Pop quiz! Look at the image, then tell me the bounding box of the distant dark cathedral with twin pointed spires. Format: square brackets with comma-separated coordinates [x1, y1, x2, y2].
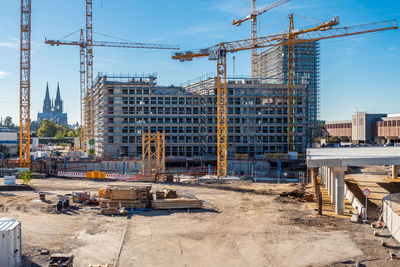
[37, 83, 68, 126]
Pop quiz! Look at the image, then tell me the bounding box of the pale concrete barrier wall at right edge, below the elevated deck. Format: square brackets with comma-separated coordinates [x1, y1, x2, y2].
[382, 193, 400, 242]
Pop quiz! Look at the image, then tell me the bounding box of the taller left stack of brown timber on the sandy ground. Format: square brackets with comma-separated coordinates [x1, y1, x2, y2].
[100, 184, 152, 214]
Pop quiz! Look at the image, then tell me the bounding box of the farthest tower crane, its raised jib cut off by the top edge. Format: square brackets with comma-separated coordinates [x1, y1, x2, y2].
[232, 0, 290, 78]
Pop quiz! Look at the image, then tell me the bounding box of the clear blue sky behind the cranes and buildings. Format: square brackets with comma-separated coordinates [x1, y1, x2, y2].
[0, 0, 400, 123]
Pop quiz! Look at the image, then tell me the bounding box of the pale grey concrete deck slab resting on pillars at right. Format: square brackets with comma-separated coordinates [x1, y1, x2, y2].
[307, 147, 400, 168]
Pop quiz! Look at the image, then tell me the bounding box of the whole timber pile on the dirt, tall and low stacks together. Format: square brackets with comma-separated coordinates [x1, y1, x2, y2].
[99, 183, 203, 215]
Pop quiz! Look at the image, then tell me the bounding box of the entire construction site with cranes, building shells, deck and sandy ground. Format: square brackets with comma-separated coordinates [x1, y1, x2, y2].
[0, 0, 400, 267]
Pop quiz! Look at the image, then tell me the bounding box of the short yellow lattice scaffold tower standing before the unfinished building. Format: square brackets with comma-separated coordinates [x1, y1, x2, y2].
[142, 131, 165, 175]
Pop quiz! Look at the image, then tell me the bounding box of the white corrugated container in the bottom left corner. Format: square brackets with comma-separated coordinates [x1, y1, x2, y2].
[0, 218, 21, 267]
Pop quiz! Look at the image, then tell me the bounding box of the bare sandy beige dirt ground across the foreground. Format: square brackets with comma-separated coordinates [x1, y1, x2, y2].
[0, 178, 400, 266]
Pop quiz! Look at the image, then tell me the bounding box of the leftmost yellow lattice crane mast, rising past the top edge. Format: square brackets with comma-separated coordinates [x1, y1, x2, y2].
[18, 0, 32, 167]
